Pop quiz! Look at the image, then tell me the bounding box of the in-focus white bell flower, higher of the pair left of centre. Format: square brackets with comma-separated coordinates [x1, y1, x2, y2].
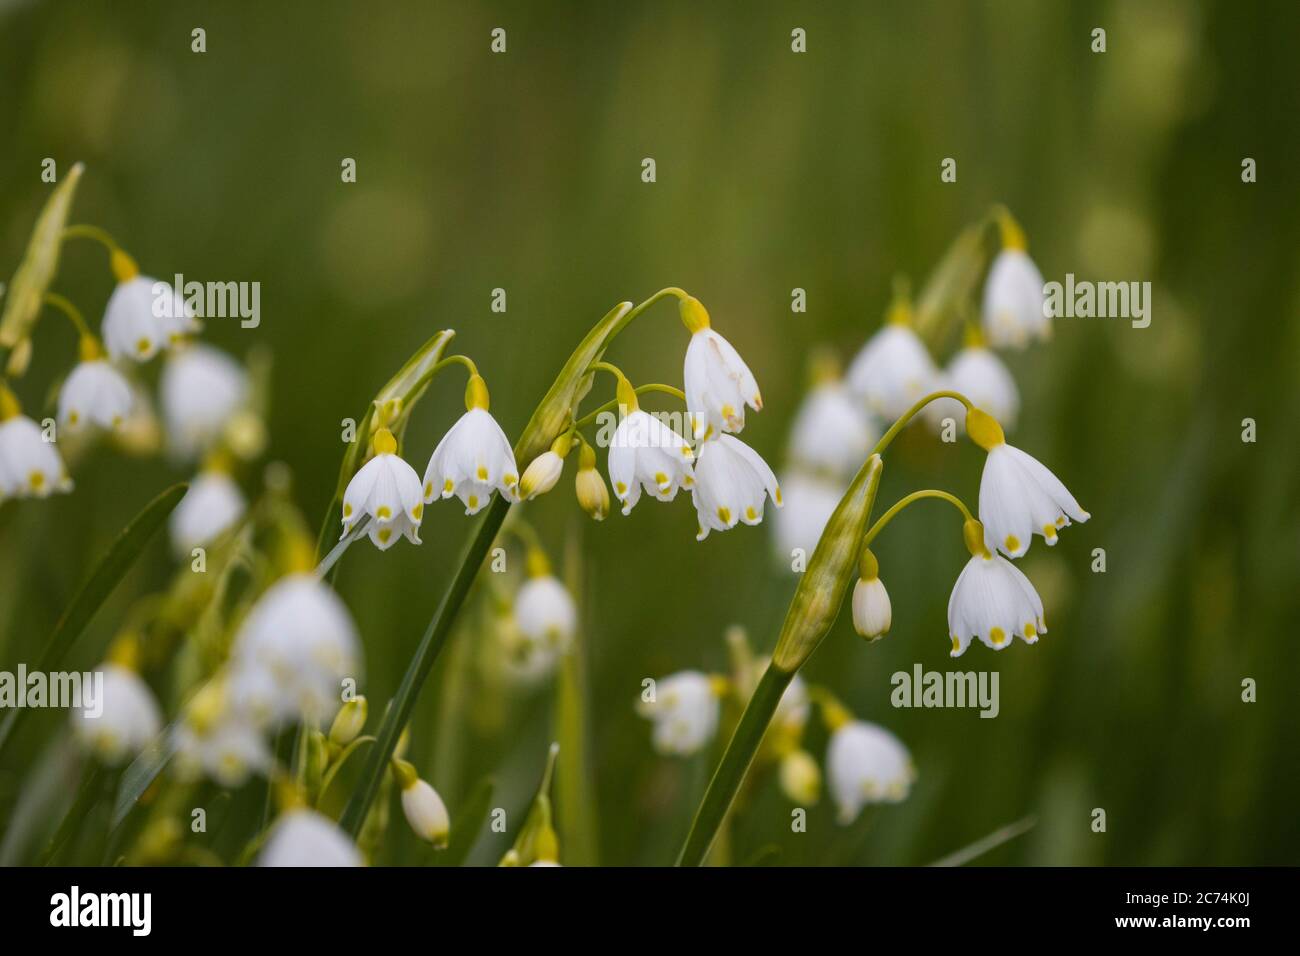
[424, 375, 519, 515]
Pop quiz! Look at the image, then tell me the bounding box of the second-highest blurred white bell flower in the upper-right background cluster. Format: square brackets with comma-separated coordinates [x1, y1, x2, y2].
[845, 310, 935, 421]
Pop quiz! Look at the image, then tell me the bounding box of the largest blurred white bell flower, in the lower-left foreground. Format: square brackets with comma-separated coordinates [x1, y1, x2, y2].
[230, 572, 360, 722]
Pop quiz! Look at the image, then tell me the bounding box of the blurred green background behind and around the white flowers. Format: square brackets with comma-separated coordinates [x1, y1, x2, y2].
[0, 0, 1300, 865]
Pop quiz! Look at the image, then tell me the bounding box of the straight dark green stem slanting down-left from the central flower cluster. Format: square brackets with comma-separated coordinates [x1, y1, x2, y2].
[338, 494, 511, 839]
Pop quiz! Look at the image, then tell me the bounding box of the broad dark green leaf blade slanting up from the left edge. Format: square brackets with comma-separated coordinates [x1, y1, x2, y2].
[0, 484, 187, 754]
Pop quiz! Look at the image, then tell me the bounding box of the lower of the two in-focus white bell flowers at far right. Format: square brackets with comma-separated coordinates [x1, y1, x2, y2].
[948, 551, 1048, 657]
